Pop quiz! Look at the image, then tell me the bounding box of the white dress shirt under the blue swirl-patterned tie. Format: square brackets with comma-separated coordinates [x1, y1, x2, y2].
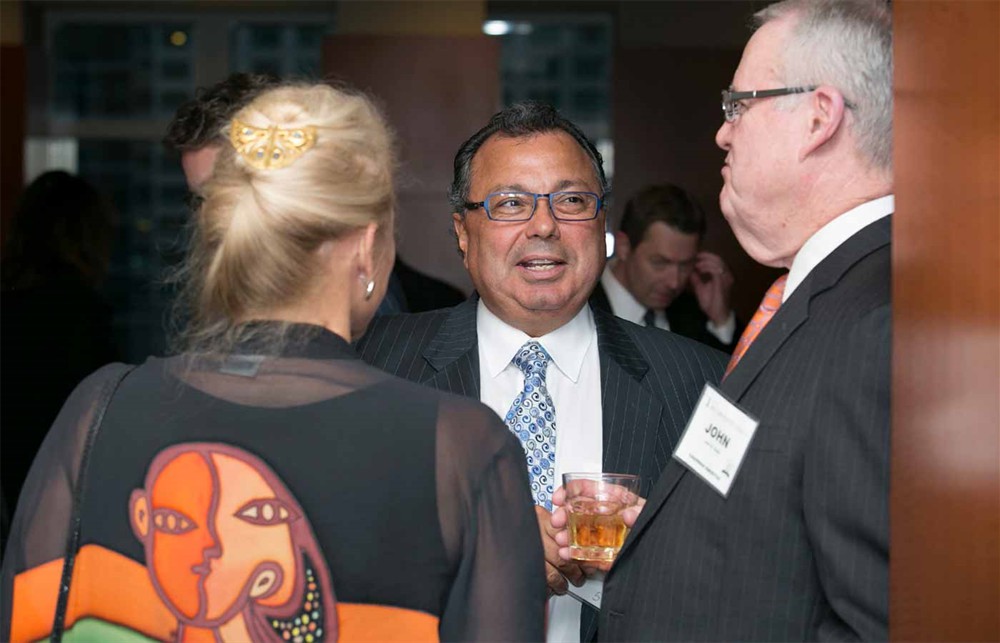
[476, 299, 604, 643]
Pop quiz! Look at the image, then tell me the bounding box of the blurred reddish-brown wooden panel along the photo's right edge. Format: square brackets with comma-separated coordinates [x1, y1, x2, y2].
[890, 0, 1000, 641]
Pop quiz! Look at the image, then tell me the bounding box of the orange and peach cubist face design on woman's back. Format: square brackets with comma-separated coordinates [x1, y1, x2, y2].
[130, 444, 332, 640]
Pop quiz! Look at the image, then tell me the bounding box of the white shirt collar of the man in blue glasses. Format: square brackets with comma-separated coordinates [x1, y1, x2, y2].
[476, 298, 597, 382]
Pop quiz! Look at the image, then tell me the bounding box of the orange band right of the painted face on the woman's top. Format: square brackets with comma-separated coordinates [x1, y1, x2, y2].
[337, 603, 438, 643]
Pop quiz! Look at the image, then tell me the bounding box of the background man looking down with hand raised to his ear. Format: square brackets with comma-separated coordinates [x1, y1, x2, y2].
[591, 183, 742, 353]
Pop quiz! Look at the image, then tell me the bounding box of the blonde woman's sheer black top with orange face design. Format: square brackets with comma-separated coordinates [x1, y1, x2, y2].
[0, 326, 545, 641]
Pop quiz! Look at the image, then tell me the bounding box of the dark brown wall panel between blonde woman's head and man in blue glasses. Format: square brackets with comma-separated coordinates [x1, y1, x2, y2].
[324, 35, 500, 292]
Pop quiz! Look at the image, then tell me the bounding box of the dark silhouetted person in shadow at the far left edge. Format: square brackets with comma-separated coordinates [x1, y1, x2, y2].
[0, 170, 119, 515]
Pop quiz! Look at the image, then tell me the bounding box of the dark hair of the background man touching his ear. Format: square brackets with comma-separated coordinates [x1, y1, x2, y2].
[618, 183, 705, 248]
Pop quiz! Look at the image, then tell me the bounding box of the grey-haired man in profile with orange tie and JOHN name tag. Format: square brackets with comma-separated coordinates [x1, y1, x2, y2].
[584, 0, 894, 641]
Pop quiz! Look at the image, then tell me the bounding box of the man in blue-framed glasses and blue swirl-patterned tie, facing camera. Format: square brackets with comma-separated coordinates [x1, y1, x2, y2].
[358, 103, 725, 640]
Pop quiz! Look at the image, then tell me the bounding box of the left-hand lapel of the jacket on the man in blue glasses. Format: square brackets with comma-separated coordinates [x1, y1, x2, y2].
[421, 295, 479, 400]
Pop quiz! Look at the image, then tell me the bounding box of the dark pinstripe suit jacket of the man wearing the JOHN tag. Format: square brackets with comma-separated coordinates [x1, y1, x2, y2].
[600, 217, 891, 641]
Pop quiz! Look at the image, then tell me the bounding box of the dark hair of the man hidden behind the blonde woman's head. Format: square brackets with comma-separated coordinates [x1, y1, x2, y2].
[163, 72, 282, 152]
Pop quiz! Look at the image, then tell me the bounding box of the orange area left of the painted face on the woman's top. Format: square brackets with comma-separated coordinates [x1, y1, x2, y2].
[11, 545, 177, 641]
